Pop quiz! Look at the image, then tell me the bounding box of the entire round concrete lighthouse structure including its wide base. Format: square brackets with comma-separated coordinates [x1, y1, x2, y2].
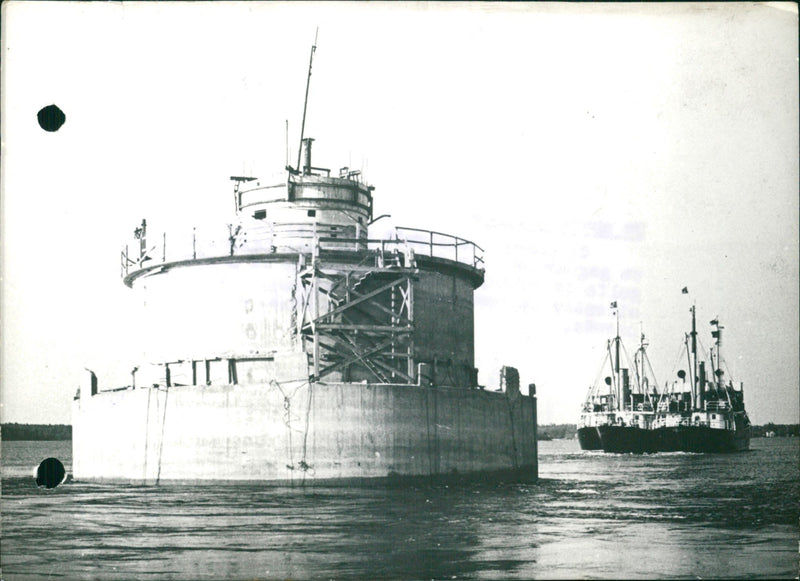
[73, 44, 537, 484]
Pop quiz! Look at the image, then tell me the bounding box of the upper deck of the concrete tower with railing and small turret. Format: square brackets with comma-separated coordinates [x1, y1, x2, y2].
[121, 138, 484, 288]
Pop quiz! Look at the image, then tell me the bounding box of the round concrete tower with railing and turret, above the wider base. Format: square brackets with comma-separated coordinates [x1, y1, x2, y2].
[122, 139, 484, 388]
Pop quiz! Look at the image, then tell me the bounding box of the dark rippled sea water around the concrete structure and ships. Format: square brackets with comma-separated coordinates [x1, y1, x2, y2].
[0, 438, 800, 580]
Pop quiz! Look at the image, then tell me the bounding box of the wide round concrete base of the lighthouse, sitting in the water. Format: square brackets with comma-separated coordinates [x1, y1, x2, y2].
[73, 382, 538, 485]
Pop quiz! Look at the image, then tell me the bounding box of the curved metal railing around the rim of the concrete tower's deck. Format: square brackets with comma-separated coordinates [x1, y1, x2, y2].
[120, 222, 484, 278]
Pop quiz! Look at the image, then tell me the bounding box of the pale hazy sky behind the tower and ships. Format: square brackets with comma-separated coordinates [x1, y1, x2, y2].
[0, 1, 800, 423]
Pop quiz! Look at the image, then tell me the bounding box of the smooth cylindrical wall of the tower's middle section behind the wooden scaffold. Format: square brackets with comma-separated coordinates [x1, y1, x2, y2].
[134, 259, 474, 387]
